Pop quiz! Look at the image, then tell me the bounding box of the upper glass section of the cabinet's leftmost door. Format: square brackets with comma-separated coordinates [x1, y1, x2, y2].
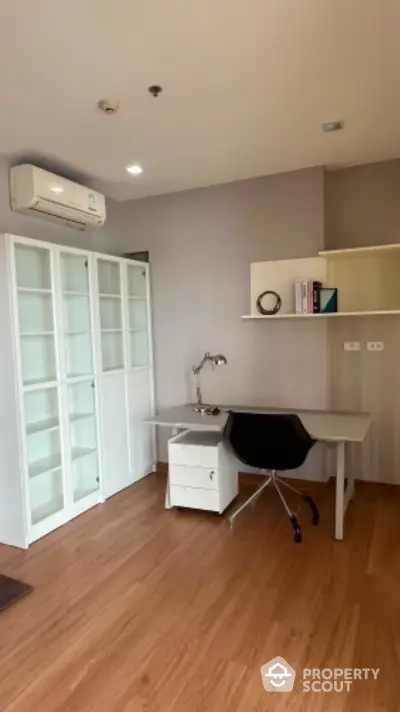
[14, 244, 57, 386]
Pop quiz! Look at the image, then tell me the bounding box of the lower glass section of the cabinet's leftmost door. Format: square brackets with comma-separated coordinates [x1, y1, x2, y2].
[24, 387, 64, 525]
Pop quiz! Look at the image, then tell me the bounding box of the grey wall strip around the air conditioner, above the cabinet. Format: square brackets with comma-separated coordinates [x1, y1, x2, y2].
[0, 160, 125, 253]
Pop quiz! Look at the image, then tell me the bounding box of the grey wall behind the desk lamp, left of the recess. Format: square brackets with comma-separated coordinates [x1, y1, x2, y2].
[115, 168, 327, 469]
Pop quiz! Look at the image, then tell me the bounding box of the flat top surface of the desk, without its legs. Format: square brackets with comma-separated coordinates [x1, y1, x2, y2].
[145, 404, 371, 442]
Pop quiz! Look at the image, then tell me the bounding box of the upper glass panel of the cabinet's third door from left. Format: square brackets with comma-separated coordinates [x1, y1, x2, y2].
[97, 259, 125, 371]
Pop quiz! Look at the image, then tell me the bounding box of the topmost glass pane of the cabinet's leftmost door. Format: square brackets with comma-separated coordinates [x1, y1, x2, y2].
[15, 244, 51, 290]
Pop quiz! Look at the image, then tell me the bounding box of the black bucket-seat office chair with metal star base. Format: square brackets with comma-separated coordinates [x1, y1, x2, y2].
[224, 411, 319, 542]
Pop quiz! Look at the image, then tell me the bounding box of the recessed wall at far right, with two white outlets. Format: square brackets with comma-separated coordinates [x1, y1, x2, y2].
[325, 160, 400, 484]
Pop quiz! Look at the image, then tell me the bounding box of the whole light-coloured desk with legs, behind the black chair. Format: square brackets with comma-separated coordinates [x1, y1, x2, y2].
[145, 405, 371, 539]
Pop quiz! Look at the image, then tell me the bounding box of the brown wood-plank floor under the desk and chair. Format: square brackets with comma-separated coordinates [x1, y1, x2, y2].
[0, 474, 400, 712]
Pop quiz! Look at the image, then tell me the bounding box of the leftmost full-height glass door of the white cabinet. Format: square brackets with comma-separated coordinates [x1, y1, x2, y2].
[14, 240, 67, 541]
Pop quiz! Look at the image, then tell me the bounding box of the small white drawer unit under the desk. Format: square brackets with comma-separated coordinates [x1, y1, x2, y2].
[168, 430, 239, 514]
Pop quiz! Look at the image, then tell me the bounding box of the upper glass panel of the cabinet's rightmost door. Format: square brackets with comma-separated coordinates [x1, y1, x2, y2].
[127, 265, 150, 368]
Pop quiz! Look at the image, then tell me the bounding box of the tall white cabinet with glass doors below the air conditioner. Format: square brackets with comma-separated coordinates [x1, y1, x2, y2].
[0, 235, 156, 548]
